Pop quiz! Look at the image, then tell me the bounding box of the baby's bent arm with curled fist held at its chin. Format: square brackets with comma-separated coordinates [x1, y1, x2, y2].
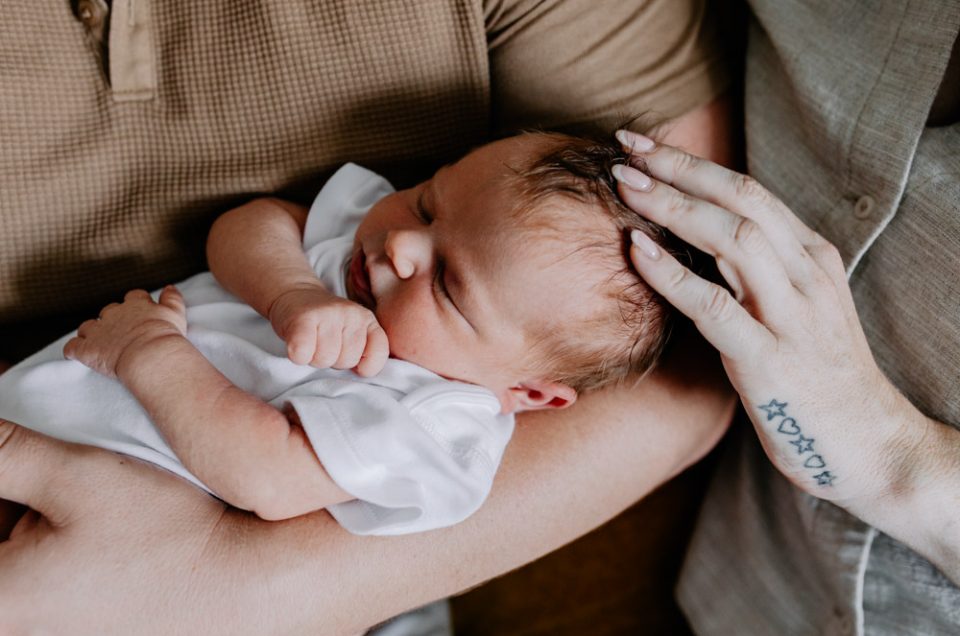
[207, 199, 389, 376]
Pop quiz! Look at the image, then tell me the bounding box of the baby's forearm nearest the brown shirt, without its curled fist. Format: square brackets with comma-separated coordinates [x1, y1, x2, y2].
[207, 199, 320, 317]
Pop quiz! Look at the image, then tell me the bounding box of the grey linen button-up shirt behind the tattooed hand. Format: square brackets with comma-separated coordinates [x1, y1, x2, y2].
[678, 0, 960, 636]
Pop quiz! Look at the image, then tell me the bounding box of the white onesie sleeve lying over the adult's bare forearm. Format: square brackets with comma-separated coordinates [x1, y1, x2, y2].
[284, 376, 514, 535]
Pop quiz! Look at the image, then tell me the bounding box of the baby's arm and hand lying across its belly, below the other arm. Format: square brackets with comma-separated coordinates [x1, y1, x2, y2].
[64, 287, 353, 520]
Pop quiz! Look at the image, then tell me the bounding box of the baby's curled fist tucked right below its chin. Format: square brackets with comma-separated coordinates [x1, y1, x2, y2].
[269, 287, 390, 377]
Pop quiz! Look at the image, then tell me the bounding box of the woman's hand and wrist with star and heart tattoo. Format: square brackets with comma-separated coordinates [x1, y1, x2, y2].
[617, 133, 960, 583]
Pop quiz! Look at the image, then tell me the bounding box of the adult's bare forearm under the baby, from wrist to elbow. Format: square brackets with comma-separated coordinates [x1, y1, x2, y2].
[191, 330, 734, 633]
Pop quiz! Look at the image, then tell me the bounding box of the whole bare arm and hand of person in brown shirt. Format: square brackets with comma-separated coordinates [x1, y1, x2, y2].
[0, 97, 733, 634]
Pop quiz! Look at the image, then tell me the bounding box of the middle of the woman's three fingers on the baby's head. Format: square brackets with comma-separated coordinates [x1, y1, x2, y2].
[614, 166, 797, 323]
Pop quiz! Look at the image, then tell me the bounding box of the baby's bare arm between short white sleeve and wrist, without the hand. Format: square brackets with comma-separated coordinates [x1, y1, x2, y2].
[117, 336, 350, 519]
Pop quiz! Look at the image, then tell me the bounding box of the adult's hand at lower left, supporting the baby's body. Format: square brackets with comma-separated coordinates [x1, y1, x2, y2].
[0, 420, 229, 634]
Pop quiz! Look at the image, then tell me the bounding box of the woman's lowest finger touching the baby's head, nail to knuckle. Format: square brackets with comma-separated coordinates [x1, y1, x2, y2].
[630, 230, 773, 359]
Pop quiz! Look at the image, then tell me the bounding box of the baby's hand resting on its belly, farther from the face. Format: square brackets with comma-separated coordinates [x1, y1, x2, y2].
[63, 285, 187, 378]
